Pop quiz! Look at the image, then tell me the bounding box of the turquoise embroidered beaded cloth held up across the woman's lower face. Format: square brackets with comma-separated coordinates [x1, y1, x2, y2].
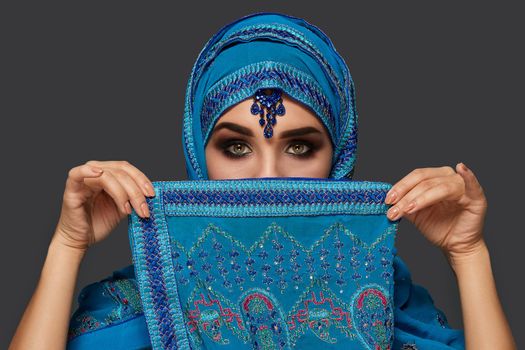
[129, 178, 397, 350]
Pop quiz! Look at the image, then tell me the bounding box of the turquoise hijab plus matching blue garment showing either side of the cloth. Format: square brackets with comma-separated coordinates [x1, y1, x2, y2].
[68, 13, 465, 349]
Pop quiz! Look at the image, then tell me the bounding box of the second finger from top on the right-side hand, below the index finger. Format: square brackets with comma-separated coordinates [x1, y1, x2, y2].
[387, 174, 465, 220]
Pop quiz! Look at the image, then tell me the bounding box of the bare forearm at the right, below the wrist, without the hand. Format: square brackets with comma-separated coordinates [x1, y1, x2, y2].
[446, 241, 516, 350]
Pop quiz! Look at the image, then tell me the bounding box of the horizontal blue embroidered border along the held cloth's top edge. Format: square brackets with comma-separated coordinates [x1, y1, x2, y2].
[159, 178, 392, 216]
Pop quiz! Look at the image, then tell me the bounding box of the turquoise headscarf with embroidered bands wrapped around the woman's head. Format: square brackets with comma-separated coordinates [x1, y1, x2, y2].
[182, 13, 357, 180]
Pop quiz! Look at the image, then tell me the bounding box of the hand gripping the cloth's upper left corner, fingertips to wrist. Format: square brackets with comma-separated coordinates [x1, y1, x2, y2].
[53, 160, 155, 253]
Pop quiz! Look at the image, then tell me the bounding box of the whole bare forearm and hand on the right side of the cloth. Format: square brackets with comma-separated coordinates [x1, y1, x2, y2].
[385, 163, 516, 350]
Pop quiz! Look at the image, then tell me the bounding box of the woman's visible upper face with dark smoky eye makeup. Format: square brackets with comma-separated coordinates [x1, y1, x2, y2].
[205, 94, 333, 180]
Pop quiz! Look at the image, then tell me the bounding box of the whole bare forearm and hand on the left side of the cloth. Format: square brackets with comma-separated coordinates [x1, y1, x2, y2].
[10, 161, 155, 349]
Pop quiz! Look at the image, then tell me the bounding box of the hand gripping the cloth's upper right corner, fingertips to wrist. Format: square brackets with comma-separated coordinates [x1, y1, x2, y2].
[385, 163, 487, 258]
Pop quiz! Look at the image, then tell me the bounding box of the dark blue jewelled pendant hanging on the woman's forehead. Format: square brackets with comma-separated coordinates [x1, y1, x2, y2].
[250, 89, 286, 139]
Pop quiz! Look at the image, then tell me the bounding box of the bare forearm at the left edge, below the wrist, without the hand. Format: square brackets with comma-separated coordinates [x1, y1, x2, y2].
[9, 235, 84, 349]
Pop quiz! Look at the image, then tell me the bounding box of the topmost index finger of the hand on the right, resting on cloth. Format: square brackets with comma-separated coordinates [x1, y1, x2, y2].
[385, 166, 455, 204]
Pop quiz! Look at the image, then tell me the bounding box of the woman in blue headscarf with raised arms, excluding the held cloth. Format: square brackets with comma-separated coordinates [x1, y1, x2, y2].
[11, 13, 515, 349]
